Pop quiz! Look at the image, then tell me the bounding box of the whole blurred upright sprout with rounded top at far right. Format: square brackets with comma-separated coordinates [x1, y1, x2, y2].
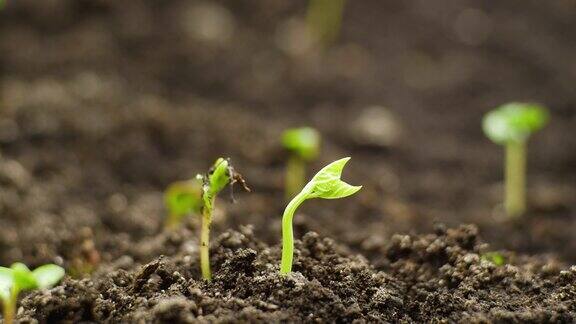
[482, 103, 549, 217]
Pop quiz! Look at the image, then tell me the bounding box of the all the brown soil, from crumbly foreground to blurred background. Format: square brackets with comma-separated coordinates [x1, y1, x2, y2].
[0, 0, 576, 323]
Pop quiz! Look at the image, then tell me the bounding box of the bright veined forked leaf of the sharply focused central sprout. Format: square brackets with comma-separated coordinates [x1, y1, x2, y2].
[305, 157, 362, 199]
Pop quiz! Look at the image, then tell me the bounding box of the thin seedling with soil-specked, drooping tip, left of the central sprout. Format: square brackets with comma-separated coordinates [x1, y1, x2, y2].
[197, 158, 250, 281]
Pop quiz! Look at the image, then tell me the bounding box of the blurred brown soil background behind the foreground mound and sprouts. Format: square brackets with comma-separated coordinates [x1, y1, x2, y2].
[0, 0, 576, 264]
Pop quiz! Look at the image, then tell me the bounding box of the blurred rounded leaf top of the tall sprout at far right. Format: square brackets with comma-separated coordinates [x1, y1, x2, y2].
[482, 102, 549, 144]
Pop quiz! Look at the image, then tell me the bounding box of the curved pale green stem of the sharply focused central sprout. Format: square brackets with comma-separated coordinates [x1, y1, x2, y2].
[280, 188, 308, 275]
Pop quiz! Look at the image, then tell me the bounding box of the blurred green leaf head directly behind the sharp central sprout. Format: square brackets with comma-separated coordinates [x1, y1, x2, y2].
[282, 127, 320, 161]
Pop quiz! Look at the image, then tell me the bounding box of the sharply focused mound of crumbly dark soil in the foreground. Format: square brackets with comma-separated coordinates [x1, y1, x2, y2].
[20, 226, 576, 323]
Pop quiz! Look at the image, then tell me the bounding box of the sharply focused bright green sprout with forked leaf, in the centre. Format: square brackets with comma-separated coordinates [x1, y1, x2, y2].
[280, 157, 362, 275]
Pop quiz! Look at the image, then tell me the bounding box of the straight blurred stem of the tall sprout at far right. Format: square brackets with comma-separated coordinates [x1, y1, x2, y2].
[504, 142, 526, 217]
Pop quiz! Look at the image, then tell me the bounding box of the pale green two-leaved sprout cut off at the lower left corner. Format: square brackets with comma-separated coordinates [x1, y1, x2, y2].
[0, 263, 64, 324]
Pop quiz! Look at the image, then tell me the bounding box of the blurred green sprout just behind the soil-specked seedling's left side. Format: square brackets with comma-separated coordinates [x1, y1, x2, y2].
[164, 178, 204, 228]
